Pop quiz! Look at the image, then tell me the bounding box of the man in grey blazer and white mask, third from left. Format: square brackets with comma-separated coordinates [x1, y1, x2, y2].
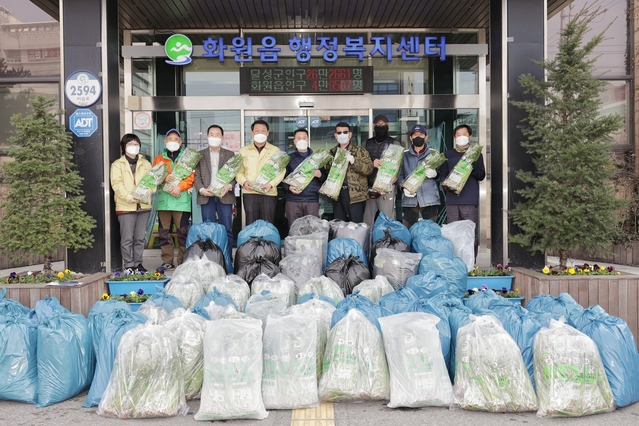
[194, 124, 235, 247]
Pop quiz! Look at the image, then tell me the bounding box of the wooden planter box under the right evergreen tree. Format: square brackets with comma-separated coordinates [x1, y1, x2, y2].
[512, 268, 639, 348]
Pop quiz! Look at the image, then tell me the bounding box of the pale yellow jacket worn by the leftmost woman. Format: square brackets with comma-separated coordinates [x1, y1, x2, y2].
[110, 154, 151, 212]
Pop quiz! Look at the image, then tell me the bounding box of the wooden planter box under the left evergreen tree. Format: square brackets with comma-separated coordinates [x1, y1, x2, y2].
[3, 272, 110, 316]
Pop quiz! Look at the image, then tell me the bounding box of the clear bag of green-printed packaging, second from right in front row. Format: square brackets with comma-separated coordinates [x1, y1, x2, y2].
[453, 315, 538, 412]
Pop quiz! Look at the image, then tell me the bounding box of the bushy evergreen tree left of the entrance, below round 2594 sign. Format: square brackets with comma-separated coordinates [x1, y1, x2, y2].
[0, 96, 95, 272]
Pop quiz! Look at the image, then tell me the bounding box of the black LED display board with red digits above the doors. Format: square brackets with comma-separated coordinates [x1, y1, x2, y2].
[240, 66, 373, 95]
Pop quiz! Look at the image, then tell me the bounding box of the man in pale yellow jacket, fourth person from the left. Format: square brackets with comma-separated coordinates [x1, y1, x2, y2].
[235, 120, 286, 225]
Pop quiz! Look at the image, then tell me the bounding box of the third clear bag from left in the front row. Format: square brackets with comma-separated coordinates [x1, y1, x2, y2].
[262, 314, 319, 410]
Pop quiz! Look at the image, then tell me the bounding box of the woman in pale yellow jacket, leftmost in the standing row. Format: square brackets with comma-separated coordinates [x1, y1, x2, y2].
[110, 133, 151, 273]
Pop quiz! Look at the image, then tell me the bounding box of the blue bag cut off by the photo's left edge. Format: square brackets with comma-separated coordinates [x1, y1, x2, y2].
[0, 314, 38, 404]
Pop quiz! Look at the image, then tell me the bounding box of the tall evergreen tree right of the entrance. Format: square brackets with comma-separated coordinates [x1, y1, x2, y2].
[510, 10, 623, 267]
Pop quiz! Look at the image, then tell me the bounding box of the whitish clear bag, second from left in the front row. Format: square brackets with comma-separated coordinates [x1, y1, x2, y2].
[195, 319, 268, 420]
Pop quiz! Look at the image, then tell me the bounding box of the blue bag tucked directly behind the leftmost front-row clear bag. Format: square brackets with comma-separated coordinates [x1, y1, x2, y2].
[82, 303, 147, 408]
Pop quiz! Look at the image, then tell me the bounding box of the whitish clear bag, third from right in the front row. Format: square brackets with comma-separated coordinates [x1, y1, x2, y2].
[379, 312, 453, 408]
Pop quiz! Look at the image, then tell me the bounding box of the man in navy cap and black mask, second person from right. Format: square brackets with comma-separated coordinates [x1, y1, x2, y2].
[397, 124, 440, 228]
